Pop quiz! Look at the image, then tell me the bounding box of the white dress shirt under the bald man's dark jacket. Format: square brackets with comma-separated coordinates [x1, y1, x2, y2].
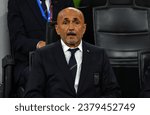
[61, 40, 83, 92]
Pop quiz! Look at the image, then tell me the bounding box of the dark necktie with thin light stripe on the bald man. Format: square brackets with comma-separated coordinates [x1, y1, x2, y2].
[68, 48, 79, 81]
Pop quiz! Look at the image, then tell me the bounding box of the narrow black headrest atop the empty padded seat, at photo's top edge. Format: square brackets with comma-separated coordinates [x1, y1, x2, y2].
[107, 0, 134, 5]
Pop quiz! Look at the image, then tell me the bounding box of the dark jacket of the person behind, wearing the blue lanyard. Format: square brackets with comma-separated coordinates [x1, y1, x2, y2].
[8, 0, 73, 86]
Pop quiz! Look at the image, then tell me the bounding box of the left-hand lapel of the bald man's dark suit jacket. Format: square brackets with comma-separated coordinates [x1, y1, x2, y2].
[54, 40, 75, 95]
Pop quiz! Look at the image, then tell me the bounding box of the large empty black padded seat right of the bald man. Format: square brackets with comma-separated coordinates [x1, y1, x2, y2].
[93, 0, 150, 97]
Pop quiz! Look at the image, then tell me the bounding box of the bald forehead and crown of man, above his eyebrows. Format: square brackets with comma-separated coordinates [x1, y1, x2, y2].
[57, 9, 84, 22]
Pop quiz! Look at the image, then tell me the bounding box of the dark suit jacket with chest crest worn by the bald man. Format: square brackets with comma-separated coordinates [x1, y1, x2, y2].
[25, 41, 120, 98]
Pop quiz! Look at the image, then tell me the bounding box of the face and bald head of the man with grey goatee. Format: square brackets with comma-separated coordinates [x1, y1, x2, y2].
[56, 9, 86, 47]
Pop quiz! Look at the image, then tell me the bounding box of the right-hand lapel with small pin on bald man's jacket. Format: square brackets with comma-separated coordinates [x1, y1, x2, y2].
[78, 42, 90, 93]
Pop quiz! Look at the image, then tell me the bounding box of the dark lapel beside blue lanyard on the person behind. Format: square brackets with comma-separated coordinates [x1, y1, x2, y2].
[27, 0, 46, 29]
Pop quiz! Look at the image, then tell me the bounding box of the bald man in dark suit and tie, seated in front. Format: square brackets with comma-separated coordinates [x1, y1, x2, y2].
[25, 7, 120, 98]
